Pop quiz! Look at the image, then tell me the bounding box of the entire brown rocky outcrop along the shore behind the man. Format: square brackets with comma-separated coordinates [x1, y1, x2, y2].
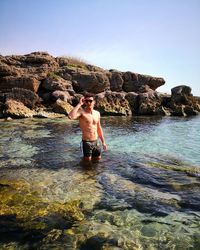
[0, 52, 200, 118]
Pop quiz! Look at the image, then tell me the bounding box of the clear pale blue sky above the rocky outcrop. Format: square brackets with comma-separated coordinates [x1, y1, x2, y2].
[0, 0, 200, 96]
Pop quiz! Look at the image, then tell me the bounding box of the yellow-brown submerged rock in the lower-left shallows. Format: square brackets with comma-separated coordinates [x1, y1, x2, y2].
[0, 180, 84, 241]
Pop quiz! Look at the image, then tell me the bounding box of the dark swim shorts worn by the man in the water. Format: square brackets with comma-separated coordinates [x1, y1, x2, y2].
[82, 140, 101, 157]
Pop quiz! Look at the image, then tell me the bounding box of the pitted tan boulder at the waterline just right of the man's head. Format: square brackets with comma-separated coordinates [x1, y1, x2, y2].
[95, 91, 132, 116]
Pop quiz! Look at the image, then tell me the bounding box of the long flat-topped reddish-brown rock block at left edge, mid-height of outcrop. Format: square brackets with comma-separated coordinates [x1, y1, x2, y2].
[0, 76, 40, 93]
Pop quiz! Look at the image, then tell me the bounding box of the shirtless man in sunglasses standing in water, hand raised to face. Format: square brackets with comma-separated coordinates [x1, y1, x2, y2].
[68, 94, 107, 161]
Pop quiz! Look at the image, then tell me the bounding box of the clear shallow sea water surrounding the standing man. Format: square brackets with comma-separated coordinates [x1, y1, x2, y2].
[0, 117, 200, 250]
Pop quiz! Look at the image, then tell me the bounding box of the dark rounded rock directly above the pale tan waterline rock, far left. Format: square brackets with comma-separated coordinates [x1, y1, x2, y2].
[5, 88, 40, 108]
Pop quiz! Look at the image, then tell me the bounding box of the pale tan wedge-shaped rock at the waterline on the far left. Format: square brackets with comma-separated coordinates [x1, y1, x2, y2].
[4, 99, 35, 118]
